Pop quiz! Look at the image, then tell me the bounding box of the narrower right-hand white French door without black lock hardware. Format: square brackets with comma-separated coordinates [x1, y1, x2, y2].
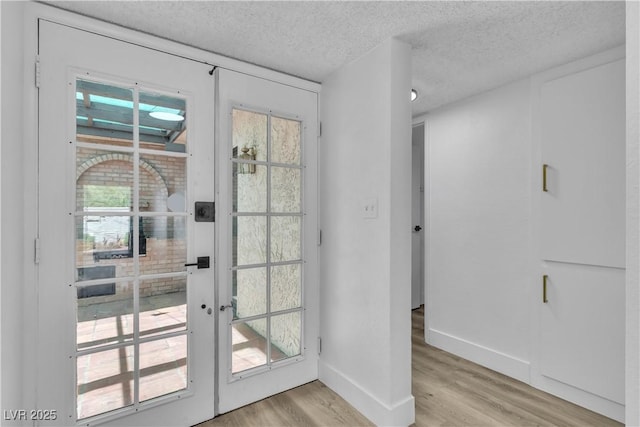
[216, 69, 319, 413]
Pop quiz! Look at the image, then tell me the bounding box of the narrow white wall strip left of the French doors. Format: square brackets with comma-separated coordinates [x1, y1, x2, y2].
[0, 2, 25, 425]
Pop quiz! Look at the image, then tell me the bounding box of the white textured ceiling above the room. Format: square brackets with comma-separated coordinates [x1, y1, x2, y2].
[46, 1, 625, 115]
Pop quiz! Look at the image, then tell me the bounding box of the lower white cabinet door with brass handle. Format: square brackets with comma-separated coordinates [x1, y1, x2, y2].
[540, 262, 625, 405]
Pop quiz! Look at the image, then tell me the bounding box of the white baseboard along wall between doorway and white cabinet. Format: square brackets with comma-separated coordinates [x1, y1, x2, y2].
[427, 329, 531, 384]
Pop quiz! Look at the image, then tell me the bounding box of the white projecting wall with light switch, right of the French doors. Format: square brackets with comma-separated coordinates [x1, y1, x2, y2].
[320, 40, 414, 425]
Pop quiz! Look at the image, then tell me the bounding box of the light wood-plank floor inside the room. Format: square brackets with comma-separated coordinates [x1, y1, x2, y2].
[199, 309, 622, 427]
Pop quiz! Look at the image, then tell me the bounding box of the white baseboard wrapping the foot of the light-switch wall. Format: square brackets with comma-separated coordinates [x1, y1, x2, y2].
[319, 361, 415, 426]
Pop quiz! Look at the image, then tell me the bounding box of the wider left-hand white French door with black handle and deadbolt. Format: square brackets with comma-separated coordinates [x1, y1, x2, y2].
[34, 21, 217, 426]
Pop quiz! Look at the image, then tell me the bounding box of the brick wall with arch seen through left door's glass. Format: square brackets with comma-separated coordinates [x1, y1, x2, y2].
[76, 148, 186, 305]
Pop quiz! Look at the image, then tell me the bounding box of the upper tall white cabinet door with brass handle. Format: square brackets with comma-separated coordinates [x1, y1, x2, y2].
[540, 59, 625, 268]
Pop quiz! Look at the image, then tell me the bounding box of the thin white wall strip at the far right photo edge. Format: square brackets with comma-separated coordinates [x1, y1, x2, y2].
[625, 2, 640, 426]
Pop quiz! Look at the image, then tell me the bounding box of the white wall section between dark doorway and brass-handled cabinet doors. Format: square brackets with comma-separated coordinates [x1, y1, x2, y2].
[425, 81, 531, 381]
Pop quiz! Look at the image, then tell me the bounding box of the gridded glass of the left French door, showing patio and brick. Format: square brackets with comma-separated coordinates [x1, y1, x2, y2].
[75, 80, 188, 419]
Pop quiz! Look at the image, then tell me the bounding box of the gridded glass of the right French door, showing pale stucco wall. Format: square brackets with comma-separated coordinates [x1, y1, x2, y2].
[230, 108, 303, 379]
